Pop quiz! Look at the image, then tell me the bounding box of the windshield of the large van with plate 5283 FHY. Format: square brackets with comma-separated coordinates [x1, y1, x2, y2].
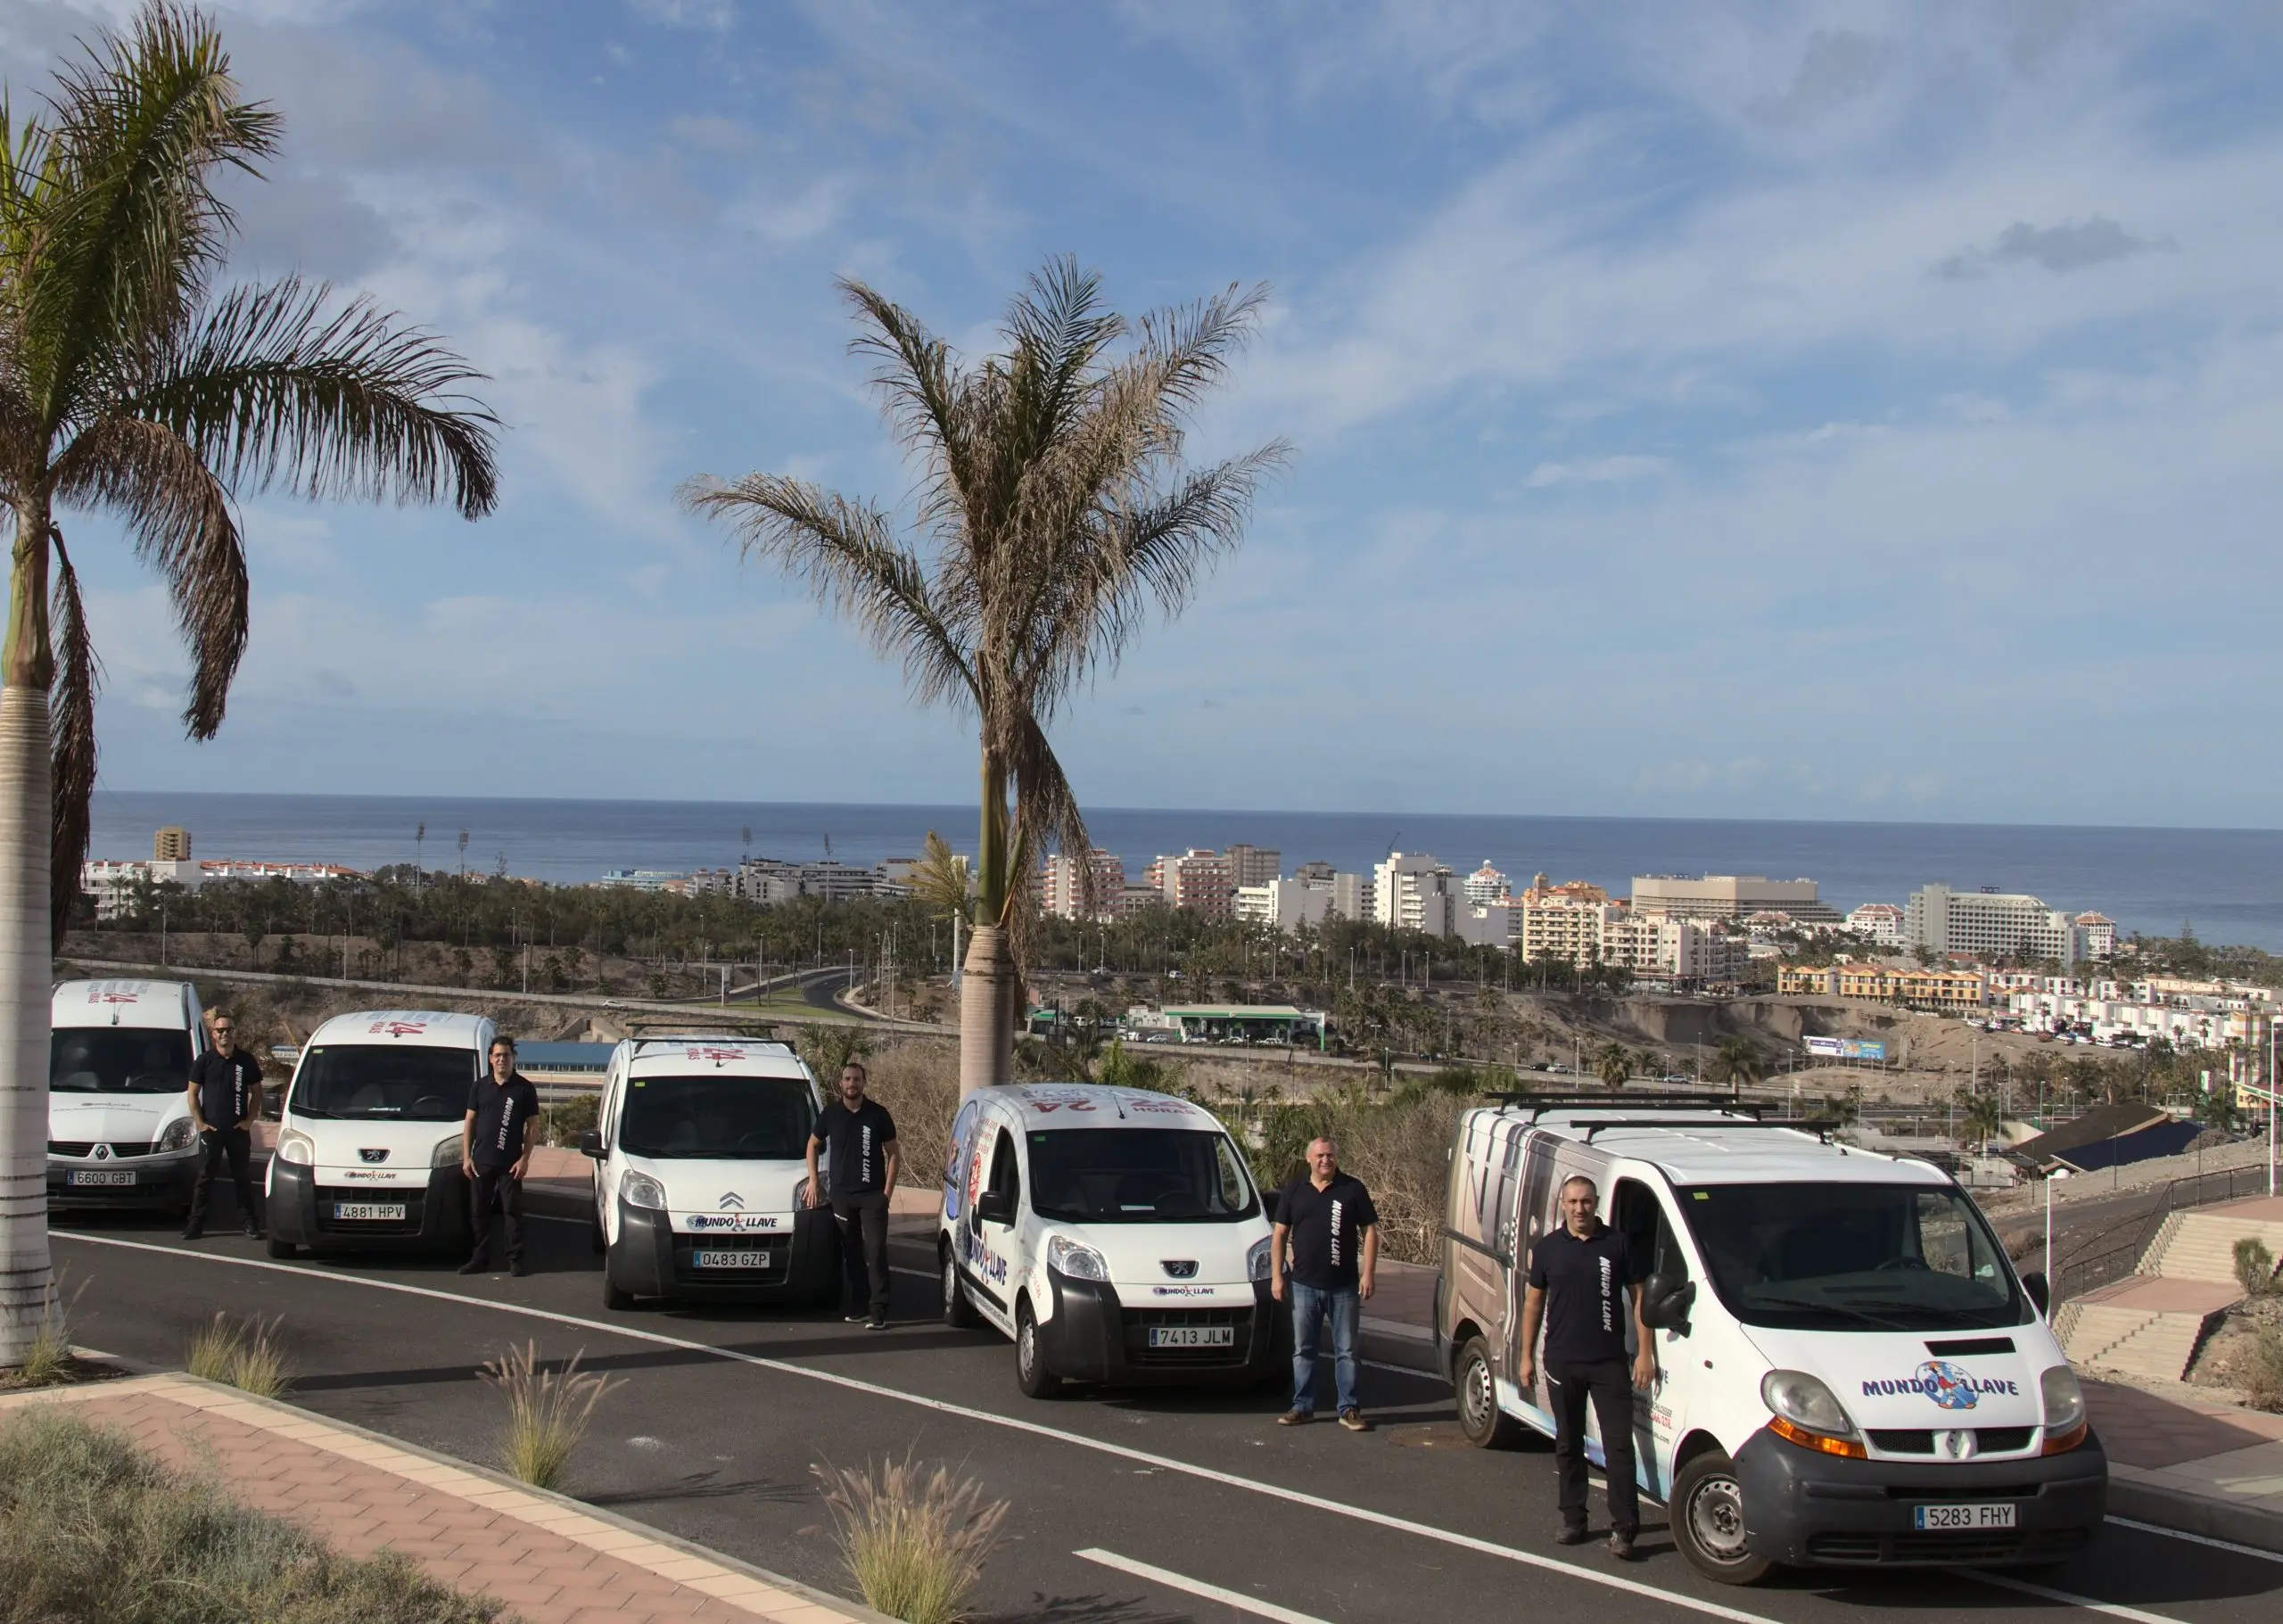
[1678, 1183, 2023, 1331]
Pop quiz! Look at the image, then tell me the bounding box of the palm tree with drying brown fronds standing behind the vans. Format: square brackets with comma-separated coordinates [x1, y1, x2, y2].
[682, 258, 1285, 1094]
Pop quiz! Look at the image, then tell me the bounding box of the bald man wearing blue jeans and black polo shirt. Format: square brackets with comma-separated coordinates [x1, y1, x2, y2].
[1269, 1140, 1379, 1432]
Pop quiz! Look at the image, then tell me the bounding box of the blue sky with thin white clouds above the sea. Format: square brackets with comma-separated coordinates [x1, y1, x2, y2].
[0, 0, 2283, 827]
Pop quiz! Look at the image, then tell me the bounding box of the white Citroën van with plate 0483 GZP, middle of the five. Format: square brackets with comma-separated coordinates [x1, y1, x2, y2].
[580, 1035, 840, 1309]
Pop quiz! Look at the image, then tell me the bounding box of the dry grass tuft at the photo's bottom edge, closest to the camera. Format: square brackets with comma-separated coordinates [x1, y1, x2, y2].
[811, 1452, 1007, 1624]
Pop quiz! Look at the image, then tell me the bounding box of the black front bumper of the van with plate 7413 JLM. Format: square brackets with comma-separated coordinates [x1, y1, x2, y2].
[1039, 1270, 1292, 1387]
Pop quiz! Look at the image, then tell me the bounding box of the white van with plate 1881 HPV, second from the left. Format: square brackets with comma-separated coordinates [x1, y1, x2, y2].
[268, 1010, 493, 1258]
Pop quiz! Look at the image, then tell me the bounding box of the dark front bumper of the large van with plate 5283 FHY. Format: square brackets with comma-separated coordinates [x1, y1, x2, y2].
[1735, 1432, 2109, 1567]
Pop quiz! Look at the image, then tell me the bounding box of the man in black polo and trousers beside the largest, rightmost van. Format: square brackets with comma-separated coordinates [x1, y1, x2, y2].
[1518, 1176, 1658, 1560]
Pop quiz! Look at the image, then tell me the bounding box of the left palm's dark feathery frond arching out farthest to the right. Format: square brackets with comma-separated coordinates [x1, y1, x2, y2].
[123, 276, 500, 518]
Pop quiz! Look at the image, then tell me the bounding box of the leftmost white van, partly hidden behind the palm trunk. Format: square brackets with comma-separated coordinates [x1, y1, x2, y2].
[48, 982, 205, 1216]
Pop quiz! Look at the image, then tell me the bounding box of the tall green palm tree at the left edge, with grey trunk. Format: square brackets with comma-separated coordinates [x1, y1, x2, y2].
[0, 0, 498, 1366]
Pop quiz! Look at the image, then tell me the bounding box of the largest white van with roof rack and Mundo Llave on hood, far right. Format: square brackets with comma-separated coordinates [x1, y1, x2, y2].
[1436, 1099, 2107, 1585]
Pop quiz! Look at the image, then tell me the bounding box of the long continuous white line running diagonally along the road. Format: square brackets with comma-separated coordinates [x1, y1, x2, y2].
[54, 1229, 1762, 1624]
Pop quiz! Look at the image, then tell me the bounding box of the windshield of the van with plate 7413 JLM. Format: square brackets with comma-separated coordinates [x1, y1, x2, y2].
[1030, 1128, 1258, 1224]
